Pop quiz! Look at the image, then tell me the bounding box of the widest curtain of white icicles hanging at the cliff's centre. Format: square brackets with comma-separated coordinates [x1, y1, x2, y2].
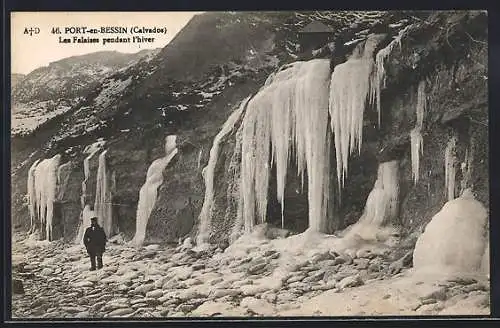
[240, 59, 330, 232]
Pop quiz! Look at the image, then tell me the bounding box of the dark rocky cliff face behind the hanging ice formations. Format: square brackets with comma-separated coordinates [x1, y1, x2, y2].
[12, 12, 489, 251]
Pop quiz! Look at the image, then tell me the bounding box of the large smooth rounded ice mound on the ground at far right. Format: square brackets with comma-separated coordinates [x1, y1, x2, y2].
[413, 189, 488, 273]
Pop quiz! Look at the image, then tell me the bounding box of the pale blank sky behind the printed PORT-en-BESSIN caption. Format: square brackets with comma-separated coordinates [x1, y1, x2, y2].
[11, 12, 200, 74]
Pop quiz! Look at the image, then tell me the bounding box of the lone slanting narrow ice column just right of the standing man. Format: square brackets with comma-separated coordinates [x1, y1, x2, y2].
[132, 135, 178, 246]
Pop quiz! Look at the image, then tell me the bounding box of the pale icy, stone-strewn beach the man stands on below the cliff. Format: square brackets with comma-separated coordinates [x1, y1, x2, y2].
[12, 226, 489, 318]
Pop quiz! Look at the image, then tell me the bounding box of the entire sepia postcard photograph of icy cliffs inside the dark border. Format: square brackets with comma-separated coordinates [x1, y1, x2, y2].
[7, 10, 491, 321]
